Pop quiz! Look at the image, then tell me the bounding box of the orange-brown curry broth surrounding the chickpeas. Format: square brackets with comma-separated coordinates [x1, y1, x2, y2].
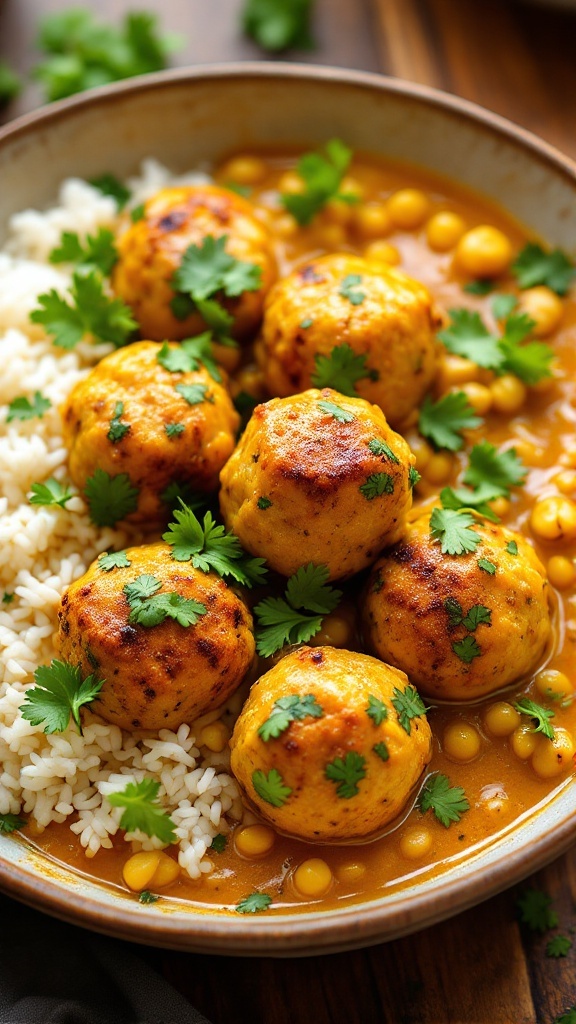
[25, 154, 576, 911]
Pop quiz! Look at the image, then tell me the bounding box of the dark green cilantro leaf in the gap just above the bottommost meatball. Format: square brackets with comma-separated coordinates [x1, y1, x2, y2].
[254, 562, 342, 657]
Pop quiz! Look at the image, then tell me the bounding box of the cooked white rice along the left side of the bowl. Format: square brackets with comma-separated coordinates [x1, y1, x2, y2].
[0, 161, 243, 879]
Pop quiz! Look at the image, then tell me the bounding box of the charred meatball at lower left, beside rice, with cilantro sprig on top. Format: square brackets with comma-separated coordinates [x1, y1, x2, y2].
[55, 543, 254, 730]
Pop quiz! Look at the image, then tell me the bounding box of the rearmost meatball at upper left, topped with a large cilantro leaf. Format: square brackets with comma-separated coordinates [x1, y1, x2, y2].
[112, 185, 276, 341]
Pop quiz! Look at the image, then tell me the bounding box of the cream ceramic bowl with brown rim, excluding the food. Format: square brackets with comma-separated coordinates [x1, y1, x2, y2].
[0, 63, 576, 955]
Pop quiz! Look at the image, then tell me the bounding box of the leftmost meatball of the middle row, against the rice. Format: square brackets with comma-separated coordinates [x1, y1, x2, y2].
[63, 341, 240, 523]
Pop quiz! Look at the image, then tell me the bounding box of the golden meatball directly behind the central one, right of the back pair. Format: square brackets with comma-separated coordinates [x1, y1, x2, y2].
[258, 255, 437, 426]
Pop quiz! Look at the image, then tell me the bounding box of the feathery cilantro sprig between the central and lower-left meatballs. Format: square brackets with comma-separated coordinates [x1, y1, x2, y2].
[162, 502, 266, 587]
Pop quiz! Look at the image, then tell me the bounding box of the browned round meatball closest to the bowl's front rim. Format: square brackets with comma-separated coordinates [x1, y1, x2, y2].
[231, 647, 431, 842]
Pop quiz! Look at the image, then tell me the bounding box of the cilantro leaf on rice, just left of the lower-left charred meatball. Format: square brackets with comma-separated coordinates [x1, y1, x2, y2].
[20, 659, 105, 734]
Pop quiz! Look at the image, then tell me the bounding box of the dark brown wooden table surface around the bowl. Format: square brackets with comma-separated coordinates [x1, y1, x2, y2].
[0, 0, 576, 1024]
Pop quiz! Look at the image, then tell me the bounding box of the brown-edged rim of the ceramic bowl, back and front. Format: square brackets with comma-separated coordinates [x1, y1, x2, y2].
[0, 61, 576, 955]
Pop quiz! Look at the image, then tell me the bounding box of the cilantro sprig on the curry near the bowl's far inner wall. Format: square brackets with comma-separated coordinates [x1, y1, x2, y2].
[282, 138, 356, 225]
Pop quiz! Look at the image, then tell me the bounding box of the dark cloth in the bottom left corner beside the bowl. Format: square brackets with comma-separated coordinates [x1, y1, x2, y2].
[0, 896, 210, 1024]
